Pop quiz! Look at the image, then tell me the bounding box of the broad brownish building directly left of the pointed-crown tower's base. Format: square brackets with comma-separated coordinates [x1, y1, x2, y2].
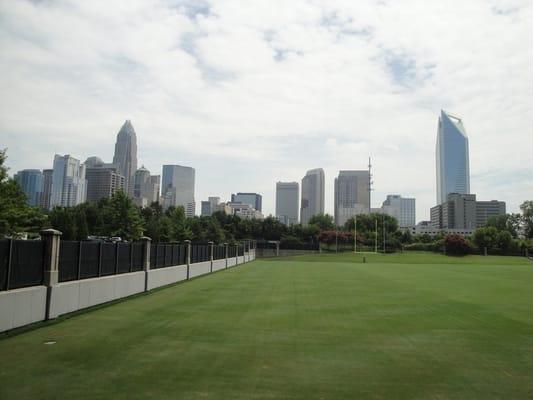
[85, 157, 126, 202]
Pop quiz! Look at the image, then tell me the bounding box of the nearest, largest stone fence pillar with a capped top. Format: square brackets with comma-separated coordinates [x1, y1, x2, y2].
[40, 229, 62, 319]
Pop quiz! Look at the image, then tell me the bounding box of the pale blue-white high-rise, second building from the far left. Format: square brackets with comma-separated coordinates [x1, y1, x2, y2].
[50, 154, 87, 207]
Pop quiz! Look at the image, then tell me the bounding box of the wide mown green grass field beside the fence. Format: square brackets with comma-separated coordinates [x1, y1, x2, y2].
[0, 254, 533, 400]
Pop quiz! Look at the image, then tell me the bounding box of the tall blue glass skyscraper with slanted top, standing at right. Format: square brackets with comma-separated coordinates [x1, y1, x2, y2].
[436, 111, 470, 204]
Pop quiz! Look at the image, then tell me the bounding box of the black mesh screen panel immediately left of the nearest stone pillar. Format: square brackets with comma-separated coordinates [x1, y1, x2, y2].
[8, 240, 44, 289]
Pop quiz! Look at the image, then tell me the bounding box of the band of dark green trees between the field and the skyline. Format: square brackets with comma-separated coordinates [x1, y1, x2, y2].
[0, 150, 533, 253]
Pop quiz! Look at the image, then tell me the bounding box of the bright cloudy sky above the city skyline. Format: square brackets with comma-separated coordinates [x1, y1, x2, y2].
[0, 0, 533, 221]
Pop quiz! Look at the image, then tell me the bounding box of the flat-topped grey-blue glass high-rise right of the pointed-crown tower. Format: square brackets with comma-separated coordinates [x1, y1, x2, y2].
[162, 165, 196, 217]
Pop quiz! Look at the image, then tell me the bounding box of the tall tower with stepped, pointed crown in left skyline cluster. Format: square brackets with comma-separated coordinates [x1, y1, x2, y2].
[113, 120, 137, 196]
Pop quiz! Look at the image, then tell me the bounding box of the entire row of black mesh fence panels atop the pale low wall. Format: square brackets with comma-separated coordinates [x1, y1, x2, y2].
[0, 239, 254, 291]
